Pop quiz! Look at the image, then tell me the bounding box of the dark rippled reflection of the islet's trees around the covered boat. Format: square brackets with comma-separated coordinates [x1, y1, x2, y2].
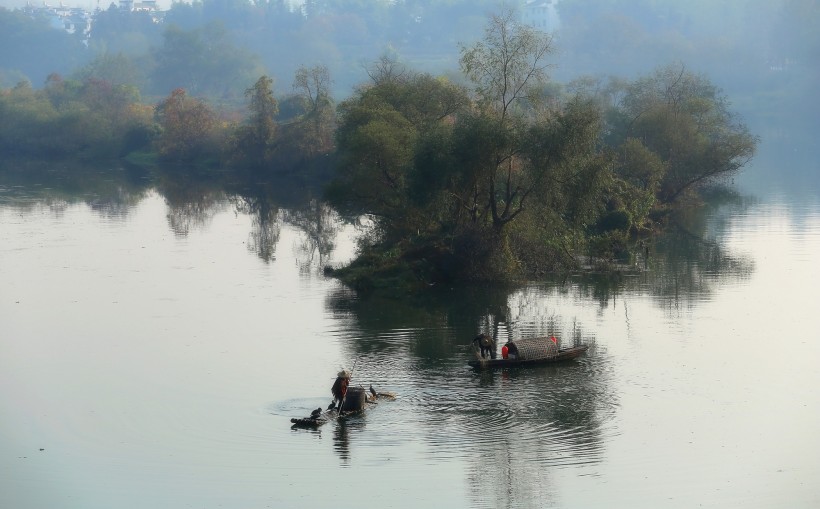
[328, 287, 616, 507]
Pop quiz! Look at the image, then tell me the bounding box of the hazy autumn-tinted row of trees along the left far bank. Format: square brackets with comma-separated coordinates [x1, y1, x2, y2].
[0, 66, 335, 172]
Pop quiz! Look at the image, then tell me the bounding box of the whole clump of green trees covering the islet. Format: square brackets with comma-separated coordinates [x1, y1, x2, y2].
[331, 14, 755, 287]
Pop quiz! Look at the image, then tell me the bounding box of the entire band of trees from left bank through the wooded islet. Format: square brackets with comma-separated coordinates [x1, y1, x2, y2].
[0, 11, 757, 288]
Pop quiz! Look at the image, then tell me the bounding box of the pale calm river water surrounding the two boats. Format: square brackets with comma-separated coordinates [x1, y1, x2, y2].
[0, 169, 820, 509]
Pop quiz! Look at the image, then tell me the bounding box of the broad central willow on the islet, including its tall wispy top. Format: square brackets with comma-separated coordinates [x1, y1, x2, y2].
[457, 8, 612, 278]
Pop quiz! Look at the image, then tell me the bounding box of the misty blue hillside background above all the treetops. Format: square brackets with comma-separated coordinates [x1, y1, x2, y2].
[0, 0, 820, 145]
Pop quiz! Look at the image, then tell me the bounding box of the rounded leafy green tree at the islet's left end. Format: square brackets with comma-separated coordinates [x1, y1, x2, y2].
[336, 66, 469, 230]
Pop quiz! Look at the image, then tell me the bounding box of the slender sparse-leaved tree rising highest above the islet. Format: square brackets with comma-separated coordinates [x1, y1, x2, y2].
[460, 11, 552, 232]
